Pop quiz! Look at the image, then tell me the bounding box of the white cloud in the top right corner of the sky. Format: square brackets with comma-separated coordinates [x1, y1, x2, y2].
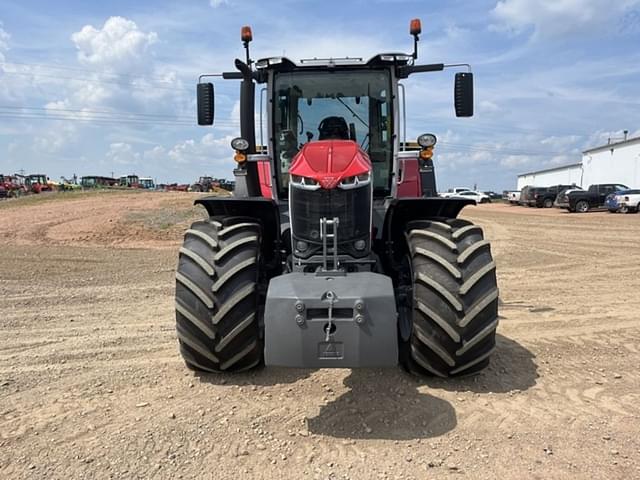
[490, 0, 640, 37]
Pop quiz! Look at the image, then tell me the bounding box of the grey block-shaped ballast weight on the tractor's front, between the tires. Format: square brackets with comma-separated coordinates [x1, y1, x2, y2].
[264, 272, 398, 368]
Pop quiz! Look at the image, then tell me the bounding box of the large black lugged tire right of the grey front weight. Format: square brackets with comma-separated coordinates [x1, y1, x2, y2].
[400, 219, 498, 377]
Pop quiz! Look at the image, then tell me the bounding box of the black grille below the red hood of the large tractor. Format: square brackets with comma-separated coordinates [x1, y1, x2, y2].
[290, 184, 371, 258]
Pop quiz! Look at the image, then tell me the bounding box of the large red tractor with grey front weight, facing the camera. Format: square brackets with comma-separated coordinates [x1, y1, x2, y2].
[176, 20, 498, 377]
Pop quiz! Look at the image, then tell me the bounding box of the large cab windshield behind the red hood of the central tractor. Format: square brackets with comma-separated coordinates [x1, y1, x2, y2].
[274, 70, 393, 197]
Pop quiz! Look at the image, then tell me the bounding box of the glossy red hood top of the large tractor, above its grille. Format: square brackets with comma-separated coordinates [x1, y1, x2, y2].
[289, 140, 371, 190]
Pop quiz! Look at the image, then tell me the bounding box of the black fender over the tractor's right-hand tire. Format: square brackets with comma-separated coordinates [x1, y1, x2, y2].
[382, 197, 475, 263]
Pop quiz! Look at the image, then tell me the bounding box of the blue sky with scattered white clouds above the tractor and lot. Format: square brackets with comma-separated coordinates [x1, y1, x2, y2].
[0, 0, 640, 190]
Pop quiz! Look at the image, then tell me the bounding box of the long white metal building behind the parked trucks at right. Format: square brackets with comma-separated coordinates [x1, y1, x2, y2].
[517, 137, 640, 190]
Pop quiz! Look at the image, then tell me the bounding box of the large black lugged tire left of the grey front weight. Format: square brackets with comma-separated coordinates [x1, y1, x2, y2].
[176, 217, 263, 372]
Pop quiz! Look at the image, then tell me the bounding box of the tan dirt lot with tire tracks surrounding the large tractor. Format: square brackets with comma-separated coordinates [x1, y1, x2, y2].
[0, 193, 640, 479]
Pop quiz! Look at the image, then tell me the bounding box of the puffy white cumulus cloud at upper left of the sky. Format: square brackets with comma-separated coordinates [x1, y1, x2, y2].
[71, 17, 158, 72]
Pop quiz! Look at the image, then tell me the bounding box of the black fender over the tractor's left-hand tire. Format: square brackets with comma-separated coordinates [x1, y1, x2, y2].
[194, 196, 280, 262]
